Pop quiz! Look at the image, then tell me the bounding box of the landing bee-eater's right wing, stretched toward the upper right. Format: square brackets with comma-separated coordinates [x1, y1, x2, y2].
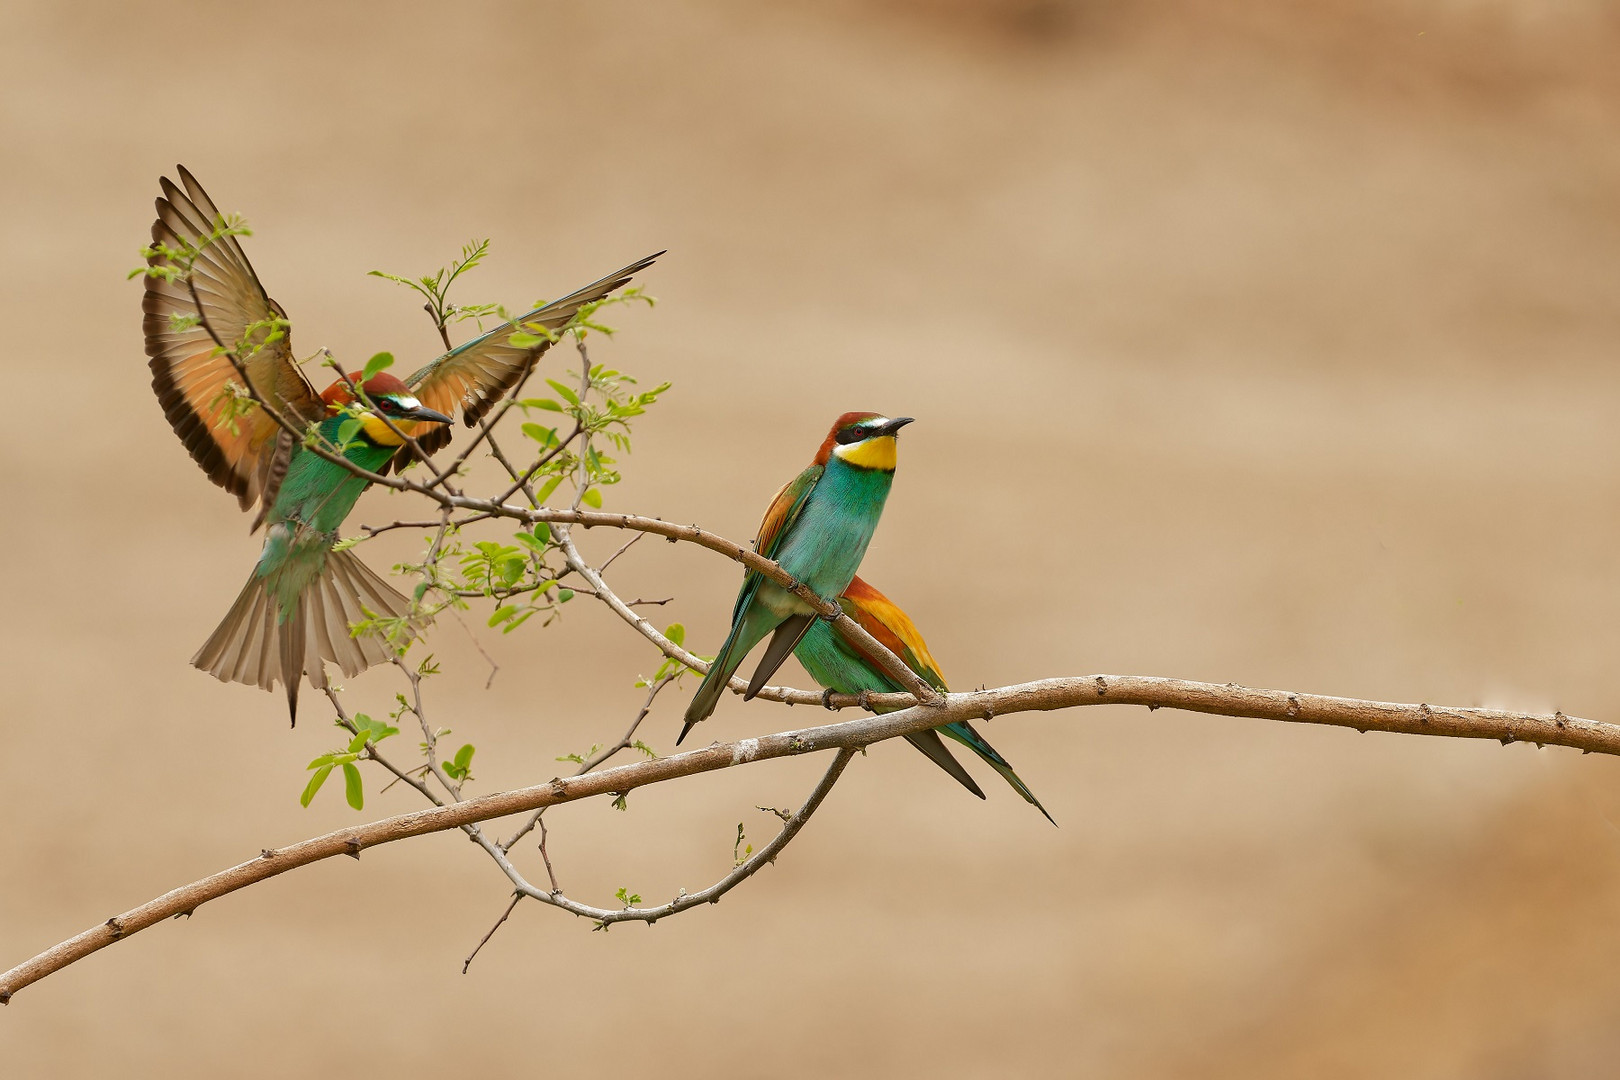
[405, 251, 664, 453]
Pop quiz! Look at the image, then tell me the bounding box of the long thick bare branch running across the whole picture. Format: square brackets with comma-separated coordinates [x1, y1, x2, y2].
[0, 675, 1620, 1004]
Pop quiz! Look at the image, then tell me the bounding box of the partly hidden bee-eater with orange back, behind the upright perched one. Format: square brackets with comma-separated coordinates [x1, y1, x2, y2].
[794, 575, 1058, 824]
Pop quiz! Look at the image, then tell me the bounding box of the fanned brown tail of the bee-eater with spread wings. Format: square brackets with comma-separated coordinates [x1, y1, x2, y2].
[191, 551, 415, 722]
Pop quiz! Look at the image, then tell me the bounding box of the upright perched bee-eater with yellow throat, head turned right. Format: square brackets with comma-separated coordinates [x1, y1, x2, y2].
[676, 413, 912, 745]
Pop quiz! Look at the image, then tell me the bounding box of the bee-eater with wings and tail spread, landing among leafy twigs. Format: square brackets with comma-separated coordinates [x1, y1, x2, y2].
[141, 167, 663, 722]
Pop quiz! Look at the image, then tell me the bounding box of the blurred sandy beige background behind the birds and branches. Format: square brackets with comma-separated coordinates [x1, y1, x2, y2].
[0, 0, 1620, 1080]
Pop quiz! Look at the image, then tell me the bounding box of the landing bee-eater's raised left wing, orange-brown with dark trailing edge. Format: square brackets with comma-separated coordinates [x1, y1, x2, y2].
[141, 165, 326, 510]
